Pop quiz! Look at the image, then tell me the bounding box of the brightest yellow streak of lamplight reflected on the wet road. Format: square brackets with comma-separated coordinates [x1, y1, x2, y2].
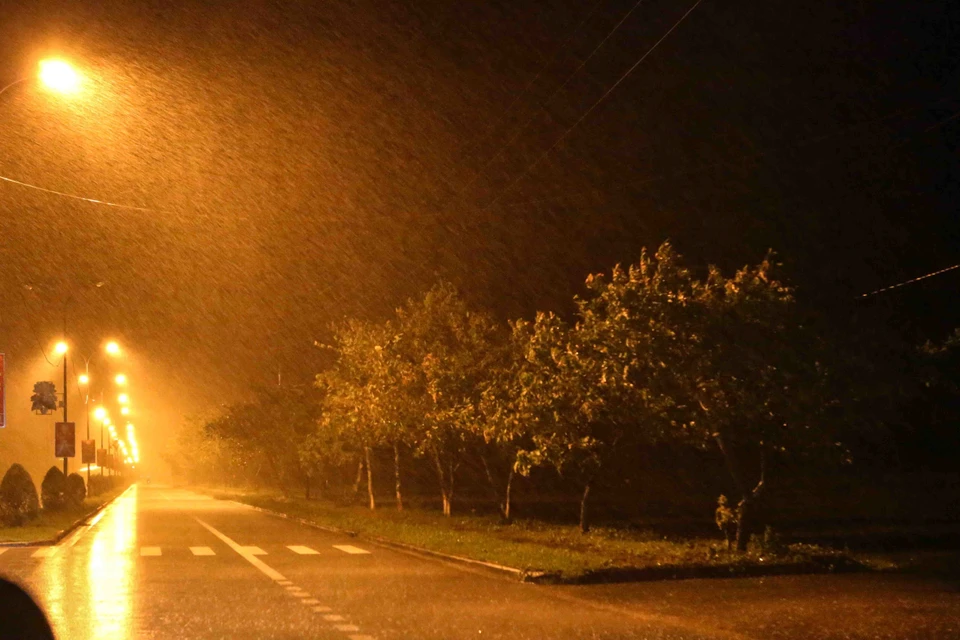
[86, 486, 137, 640]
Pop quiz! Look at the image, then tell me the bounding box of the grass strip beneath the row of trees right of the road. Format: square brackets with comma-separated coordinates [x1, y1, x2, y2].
[214, 490, 839, 579]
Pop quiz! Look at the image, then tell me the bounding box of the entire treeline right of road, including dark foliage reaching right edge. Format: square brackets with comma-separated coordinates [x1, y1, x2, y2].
[171, 243, 960, 550]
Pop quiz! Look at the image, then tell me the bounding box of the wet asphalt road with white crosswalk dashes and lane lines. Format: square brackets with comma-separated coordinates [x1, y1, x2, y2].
[0, 486, 960, 640]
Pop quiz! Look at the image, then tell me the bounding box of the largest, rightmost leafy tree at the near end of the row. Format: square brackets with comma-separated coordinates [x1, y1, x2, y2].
[579, 243, 840, 551]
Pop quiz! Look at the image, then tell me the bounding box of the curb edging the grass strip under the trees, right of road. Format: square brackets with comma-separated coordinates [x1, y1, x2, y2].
[217, 498, 870, 585]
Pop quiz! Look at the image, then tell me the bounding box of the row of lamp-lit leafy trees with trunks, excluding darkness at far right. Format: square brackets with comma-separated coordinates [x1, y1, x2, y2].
[186, 242, 875, 549]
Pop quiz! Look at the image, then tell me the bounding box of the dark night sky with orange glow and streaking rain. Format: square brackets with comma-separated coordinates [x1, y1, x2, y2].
[0, 0, 960, 476]
